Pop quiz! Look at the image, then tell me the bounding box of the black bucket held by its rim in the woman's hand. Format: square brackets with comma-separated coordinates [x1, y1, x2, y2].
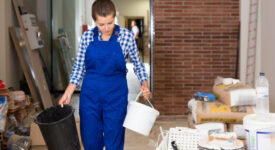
[34, 105, 80, 150]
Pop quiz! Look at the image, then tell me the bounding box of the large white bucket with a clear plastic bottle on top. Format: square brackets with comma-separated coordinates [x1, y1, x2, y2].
[243, 113, 275, 150]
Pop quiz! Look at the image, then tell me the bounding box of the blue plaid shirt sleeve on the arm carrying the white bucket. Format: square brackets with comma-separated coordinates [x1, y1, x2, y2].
[124, 28, 148, 84]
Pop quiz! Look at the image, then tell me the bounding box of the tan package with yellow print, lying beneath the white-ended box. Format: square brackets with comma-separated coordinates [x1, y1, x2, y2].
[192, 101, 254, 124]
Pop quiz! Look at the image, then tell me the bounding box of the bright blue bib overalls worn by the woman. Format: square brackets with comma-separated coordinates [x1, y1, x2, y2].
[79, 25, 128, 150]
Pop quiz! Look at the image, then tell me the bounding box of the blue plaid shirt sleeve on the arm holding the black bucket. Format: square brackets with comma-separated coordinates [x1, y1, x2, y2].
[70, 30, 93, 86]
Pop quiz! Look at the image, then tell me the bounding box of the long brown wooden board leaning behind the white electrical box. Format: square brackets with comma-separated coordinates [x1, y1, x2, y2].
[13, 0, 53, 109]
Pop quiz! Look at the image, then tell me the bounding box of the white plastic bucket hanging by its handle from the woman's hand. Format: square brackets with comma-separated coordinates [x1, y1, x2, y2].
[123, 92, 159, 136]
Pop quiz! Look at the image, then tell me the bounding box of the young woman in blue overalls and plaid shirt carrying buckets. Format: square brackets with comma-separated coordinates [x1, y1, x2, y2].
[59, 0, 150, 150]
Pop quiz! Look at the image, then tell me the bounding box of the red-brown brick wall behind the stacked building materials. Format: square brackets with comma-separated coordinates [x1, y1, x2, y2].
[154, 0, 239, 115]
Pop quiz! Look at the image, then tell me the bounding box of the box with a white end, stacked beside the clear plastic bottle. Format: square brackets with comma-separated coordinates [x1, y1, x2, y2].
[213, 83, 256, 107]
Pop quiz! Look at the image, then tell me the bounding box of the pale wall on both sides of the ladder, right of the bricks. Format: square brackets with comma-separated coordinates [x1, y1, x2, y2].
[240, 0, 275, 112]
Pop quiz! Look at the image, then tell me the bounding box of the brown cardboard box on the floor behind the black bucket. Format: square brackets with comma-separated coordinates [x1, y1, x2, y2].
[30, 118, 84, 150]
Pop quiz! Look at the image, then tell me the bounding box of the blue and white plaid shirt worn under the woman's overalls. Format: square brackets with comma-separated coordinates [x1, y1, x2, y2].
[70, 26, 148, 86]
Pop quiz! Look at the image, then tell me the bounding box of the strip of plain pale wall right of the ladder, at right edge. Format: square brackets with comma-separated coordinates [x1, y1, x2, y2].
[261, 0, 275, 112]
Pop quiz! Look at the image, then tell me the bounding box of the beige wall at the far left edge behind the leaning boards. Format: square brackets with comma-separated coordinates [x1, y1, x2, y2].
[0, 0, 23, 89]
